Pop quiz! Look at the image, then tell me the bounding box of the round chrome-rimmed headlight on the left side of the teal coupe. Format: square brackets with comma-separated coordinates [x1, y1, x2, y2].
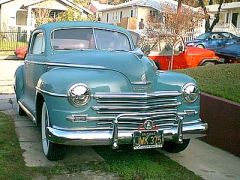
[68, 84, 91, 107]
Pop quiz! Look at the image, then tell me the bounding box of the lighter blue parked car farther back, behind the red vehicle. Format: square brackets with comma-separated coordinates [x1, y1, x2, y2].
[186, 32, 240, 50]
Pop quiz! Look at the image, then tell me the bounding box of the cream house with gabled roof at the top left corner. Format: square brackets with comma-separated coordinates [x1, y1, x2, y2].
[0, 0, 93, 35]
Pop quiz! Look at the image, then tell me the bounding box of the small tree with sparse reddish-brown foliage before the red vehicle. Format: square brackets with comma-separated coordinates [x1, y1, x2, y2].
[141, 1, 203, 70]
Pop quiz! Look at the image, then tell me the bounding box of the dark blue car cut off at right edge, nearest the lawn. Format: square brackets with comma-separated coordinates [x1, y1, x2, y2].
[216, 42, 240, 63]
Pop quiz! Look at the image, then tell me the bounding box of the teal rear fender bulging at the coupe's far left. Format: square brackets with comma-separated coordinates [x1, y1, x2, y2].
[14, 65, 24, 101]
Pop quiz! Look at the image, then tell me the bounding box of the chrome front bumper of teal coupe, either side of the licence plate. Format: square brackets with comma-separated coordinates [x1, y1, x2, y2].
[46, 119, 208, 148]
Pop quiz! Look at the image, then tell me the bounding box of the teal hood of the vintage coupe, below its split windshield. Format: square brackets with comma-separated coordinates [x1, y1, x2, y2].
[49, 50, 156, 82]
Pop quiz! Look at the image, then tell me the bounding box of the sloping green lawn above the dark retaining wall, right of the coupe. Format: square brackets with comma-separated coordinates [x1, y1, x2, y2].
[178, 64, 240, 103]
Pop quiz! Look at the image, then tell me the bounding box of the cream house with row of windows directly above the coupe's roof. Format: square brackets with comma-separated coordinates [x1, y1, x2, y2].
[100, 0, 180, 30]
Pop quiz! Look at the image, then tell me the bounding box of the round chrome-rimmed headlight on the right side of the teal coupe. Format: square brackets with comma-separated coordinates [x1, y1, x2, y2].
[182, 83, 200, 103]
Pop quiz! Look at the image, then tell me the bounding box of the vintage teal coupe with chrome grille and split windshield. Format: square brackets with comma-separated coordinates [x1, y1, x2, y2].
[15, 22, 207, 160]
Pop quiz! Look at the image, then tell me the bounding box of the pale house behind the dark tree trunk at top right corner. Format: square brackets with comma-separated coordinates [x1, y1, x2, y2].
[206, 2, 240, 35]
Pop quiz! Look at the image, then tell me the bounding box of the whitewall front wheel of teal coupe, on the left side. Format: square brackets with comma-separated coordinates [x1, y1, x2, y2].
[41, 102, 65, 161]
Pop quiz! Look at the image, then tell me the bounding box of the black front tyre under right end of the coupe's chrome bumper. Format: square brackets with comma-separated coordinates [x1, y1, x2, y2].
[163, 139, 190, 153]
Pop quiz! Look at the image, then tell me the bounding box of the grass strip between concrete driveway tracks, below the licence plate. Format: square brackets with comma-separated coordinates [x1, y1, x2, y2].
[95, 146, 201, 180]
